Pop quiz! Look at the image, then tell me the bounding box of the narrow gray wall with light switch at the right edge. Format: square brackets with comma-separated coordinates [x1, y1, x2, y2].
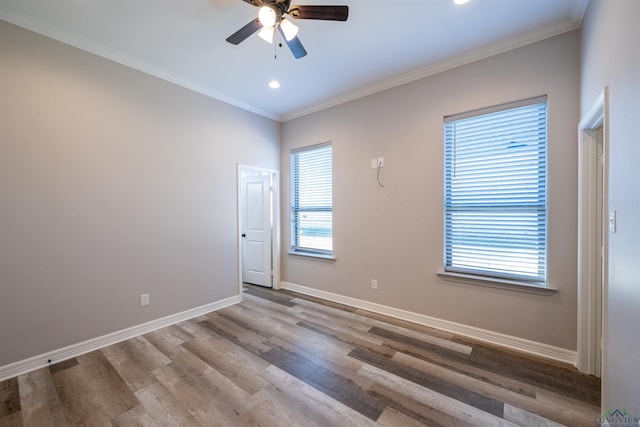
[581, 0, 640, 417]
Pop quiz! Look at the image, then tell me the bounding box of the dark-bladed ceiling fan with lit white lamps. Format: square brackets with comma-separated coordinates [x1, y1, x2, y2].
[227, 0, 349, 59]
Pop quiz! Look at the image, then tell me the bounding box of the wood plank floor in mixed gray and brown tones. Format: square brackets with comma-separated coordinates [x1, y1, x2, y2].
[0, 286, 600, 427]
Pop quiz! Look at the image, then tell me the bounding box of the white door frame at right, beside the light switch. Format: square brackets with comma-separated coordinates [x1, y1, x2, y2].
[576, 88, 609, 375]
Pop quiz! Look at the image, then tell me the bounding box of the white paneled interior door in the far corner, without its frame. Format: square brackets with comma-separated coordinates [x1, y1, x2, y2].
[242, 174, 272, 287]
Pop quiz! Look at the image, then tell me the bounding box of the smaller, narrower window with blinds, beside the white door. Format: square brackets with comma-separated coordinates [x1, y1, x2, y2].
[291, 144, 333, 256]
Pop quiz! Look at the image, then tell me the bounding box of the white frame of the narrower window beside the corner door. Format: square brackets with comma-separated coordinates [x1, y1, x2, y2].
[289, 141, 335, 260]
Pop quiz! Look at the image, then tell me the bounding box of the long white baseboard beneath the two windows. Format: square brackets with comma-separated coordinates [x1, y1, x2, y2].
[280, 282, 576, 366]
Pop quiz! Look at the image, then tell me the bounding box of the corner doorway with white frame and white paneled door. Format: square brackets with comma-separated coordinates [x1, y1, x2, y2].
[238, 165, 280, 295]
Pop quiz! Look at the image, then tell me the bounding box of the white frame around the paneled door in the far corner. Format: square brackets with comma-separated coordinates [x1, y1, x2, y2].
[237, 163, 280, 299]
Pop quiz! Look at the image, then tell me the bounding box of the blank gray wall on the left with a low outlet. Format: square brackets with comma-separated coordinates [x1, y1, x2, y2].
[0, 21, 280, 366]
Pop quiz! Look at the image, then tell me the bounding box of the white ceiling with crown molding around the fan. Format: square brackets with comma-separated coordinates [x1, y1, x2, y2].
[0, 0, 589, 121]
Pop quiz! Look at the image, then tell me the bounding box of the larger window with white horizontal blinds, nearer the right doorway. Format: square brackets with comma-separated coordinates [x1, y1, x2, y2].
[444, 97, 547, 287]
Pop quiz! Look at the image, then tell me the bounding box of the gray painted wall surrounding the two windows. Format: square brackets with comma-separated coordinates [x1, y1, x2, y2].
[281, 31, 580, 350]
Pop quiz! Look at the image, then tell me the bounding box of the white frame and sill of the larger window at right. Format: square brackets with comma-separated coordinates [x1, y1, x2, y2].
[438, 95, 554, 292]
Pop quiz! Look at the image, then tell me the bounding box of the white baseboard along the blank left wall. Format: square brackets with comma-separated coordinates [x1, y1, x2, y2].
[0, 295, 242, 381]
